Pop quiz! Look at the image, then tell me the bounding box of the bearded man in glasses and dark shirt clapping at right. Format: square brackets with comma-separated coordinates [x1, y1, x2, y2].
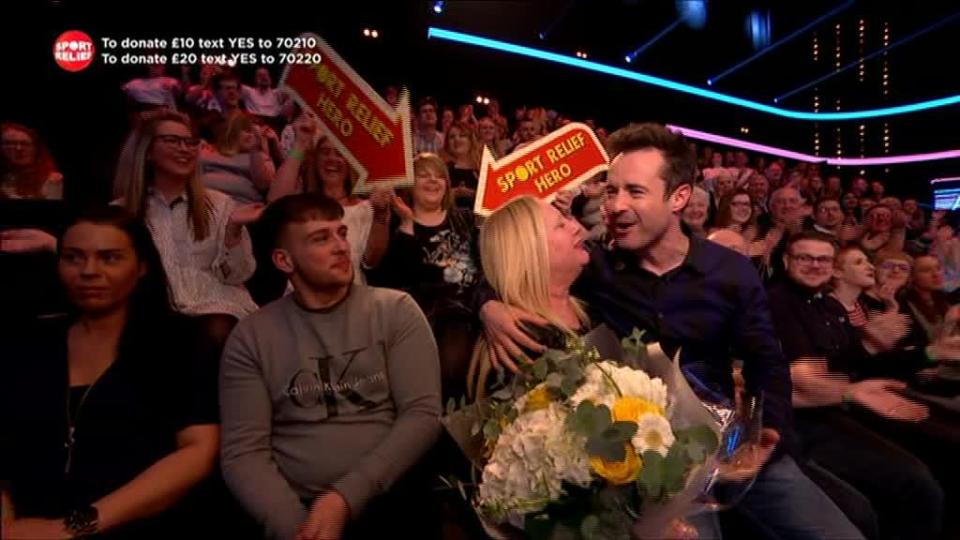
[769, 232, 943, 538]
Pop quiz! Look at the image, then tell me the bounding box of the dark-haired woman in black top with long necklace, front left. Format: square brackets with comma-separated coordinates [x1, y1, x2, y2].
[0, 207, 219, 539]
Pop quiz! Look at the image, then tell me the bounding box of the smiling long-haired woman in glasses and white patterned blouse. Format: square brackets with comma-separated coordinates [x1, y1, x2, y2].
[113, 109, 263, 349]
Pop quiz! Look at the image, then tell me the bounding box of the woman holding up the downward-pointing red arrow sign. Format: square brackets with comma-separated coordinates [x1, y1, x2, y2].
[261, 116, 393, 283]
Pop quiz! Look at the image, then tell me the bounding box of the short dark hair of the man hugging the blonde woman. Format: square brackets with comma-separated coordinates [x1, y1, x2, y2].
[607, 123, 697, 197]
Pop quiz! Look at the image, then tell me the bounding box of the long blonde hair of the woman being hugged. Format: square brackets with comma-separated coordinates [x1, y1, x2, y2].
[467, 196, 588, 398]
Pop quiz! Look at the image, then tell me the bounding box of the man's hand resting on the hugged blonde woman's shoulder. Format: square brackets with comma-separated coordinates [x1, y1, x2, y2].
[480, 300, 548, 373]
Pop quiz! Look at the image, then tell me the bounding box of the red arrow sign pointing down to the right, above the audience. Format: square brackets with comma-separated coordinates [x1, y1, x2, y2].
[281, 33, 413, 192]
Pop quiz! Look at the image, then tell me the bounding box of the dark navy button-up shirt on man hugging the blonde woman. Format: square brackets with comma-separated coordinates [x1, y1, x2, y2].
[572, 237, 792, 435]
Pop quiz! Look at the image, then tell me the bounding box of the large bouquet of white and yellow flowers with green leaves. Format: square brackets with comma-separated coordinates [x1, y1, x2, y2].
[444, 327, 719, 539]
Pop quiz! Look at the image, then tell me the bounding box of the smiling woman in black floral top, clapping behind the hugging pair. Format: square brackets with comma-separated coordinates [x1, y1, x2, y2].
[370, 154, 481, 401]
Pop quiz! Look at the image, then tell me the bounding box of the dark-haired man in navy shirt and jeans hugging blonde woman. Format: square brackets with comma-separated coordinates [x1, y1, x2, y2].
[481, 124, 861, 539]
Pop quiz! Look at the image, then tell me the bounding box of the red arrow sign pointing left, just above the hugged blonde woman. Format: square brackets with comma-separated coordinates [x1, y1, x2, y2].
[473, 123, 608, 216]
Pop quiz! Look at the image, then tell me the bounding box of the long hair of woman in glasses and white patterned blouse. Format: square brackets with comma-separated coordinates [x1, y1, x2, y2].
[113, 109, 212, 240]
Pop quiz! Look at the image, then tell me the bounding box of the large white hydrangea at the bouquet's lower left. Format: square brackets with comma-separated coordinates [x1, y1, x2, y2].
[480, 403, 591, 513]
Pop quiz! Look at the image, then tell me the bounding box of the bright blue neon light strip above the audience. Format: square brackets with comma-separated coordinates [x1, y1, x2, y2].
[427, 26, 960, 121]
